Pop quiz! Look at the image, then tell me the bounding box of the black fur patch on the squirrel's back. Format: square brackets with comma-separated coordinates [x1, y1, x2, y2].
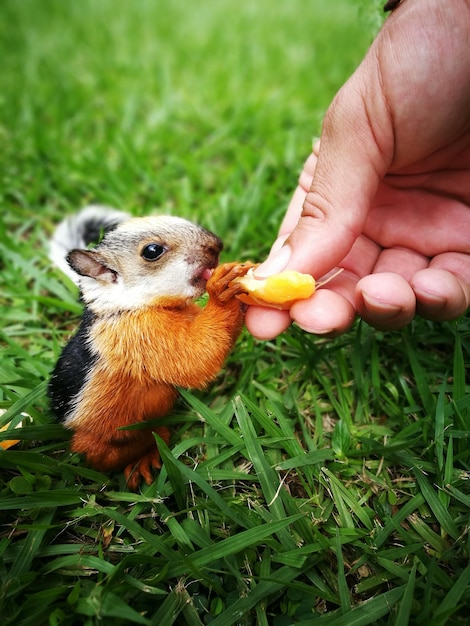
[48, 309, 97, 420]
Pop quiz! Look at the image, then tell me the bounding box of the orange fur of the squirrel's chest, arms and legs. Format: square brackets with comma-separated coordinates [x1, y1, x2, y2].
[67, 263, 251, 489]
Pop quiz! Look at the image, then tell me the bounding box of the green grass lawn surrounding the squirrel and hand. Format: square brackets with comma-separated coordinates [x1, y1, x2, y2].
[0, 0, 470, 626]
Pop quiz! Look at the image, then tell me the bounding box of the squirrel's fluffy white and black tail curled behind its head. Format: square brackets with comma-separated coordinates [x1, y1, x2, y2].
[49, 205, 131, 283]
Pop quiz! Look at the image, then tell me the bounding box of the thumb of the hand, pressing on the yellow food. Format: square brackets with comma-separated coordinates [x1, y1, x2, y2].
[256, 62, 393, 278]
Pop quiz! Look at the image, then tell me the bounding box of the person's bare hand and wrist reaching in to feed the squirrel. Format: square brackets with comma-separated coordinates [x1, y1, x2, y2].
[246, 0, 470, 339]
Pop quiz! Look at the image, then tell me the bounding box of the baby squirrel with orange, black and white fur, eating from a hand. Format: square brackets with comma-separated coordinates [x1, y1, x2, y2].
[49, 206, 252, 490]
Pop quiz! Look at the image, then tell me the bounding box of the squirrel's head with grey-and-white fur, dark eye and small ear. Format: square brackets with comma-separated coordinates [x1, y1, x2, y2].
[67, 216, 222, 313]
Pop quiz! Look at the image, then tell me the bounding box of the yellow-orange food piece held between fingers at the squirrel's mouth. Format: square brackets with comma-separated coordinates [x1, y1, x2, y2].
[236, 269, 315, 309]
